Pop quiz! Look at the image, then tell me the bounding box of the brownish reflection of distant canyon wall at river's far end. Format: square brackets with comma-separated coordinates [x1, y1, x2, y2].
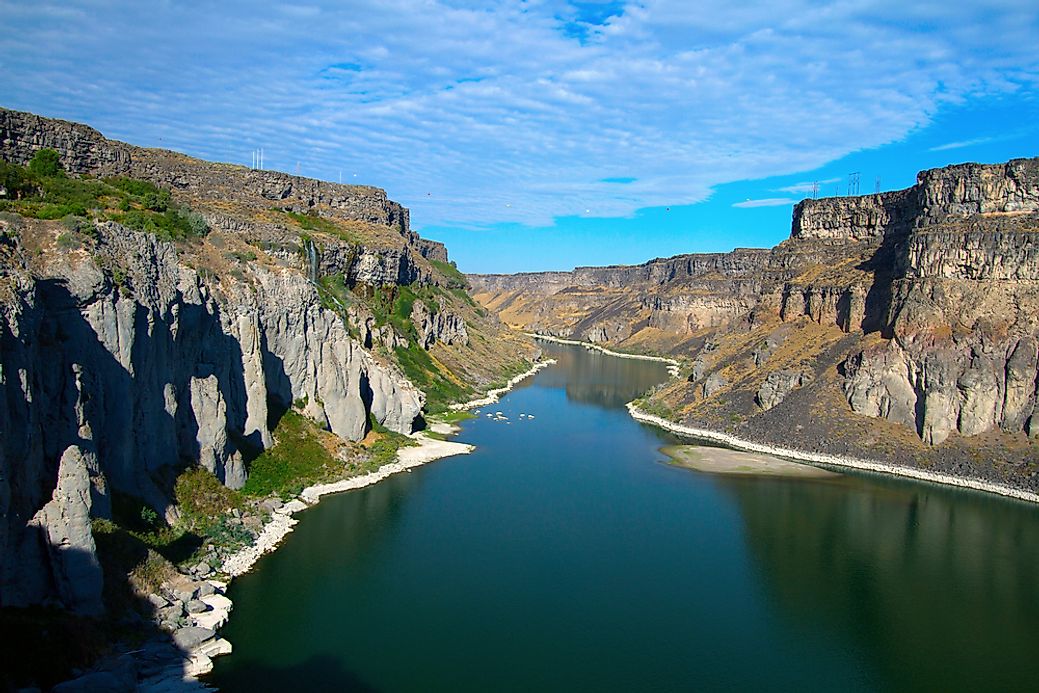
[539, 342, 668, 408]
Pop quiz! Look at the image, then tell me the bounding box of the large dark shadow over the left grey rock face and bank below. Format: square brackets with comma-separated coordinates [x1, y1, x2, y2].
[0, 279, 263, 688]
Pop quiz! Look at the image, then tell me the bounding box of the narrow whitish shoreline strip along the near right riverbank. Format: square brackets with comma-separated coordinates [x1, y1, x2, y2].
[625, 402, 1039, 503]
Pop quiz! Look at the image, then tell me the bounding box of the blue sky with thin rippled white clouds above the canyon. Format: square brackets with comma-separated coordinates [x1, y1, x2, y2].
[0, 0, 1039, 271]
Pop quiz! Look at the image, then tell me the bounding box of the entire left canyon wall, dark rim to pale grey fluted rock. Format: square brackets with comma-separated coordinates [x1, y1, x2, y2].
[0, 109, 535, 614]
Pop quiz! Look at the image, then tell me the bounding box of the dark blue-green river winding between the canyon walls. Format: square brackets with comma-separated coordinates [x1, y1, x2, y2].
[204, 347, 1039, 691]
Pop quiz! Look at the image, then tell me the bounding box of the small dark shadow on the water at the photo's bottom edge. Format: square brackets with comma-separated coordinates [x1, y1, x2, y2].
[205, 655, 378, 693]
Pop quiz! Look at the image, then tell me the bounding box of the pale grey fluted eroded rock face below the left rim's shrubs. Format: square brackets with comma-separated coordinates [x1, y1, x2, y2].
[0, 223, 424, 611]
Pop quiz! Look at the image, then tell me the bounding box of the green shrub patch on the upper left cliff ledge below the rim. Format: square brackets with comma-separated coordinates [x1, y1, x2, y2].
[0, 150, 209, 241]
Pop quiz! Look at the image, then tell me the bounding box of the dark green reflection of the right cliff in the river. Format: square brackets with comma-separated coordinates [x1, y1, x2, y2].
[718, 477, 1039, 691]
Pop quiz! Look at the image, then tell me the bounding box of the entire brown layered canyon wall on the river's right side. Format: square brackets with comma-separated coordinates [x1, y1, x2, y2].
[470, 159, 1039, 490]
